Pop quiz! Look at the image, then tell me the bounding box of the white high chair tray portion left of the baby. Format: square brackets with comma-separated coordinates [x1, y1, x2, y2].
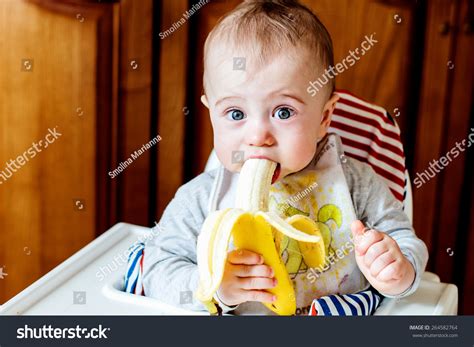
[0, 223, 204, 315]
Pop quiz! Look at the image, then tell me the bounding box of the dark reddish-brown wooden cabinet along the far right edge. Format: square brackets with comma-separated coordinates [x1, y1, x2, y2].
[412, 0, 474, 314]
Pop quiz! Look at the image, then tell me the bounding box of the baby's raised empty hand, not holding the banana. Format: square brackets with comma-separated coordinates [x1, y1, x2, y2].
[351, 220, 415, 296]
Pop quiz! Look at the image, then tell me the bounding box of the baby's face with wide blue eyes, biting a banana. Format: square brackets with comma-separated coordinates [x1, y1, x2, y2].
[202, 47, 338, 184]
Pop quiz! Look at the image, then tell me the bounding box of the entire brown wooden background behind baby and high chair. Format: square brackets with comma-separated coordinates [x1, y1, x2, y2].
[0, 0, 474, 314]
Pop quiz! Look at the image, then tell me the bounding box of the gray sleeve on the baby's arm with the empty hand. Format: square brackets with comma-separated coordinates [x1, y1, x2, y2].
[343, 158, 428, 298]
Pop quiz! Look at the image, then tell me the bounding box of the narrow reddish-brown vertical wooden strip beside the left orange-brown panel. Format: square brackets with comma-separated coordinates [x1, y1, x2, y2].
[113, 0, 153, 225]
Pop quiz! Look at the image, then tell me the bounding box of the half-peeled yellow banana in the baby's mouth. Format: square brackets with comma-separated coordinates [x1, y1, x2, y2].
[195, 159, 325, 315]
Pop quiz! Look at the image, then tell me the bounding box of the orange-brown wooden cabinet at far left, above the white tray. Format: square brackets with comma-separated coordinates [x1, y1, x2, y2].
[0, 0, 153, 302]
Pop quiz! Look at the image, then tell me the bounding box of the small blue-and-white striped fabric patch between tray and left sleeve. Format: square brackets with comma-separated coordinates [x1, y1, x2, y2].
[124, 242, 145, 295]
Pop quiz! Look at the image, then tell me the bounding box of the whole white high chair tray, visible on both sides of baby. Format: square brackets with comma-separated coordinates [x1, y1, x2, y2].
[0, 223, 457, 315]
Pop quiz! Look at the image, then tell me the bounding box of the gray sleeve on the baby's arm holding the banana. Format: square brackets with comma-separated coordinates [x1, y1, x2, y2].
[143, 172, 213, 311]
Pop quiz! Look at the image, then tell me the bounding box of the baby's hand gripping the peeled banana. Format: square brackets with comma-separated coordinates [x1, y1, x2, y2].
[217, 249, 276, 306]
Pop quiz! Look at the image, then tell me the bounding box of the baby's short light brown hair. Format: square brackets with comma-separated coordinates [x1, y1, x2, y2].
[204, 0, 334, 95]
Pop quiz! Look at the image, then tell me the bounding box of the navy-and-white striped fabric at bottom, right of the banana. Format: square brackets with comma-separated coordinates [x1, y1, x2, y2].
[308, 289, 382, 316]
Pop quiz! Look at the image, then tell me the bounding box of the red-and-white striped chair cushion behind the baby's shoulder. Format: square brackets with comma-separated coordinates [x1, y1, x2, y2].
[329, 90, 406, 202]
